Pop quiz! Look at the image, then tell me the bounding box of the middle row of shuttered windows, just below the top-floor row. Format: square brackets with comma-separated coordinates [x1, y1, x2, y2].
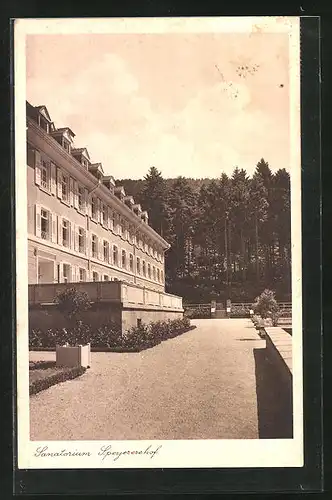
[36, 205, 164, 283]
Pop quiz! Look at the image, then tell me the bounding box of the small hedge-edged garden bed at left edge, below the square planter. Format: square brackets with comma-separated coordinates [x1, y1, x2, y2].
[29, 361, 86, 396]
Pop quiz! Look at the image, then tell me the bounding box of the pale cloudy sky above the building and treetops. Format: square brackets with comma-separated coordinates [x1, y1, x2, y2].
[26, 32, 290, 179]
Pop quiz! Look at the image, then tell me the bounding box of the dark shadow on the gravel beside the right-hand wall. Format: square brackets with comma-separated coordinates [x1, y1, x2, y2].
[254, 349, 293, 439]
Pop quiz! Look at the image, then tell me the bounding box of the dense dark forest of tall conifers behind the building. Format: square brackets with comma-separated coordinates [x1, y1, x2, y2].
[118, 159, 291, 303]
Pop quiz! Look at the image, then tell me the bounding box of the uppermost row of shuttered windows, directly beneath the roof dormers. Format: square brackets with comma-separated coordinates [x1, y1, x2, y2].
[35, 151, 164, 262]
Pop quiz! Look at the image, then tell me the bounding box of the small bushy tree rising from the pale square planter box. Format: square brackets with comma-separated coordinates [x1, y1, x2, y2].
[54, 288, 91, 340]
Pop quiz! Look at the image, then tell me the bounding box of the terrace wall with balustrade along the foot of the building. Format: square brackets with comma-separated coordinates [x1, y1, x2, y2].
[29, 281, 183, 331]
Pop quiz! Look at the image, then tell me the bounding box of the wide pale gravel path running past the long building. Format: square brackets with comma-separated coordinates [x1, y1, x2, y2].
[30, 319, 265, 440]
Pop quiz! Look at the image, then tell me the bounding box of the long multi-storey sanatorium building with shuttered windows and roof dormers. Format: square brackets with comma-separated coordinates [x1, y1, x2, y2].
[26, 103, 169, 292]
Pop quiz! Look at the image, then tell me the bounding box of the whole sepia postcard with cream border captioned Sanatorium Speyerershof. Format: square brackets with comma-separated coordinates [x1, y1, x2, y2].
[14, 17, 303, 469]
